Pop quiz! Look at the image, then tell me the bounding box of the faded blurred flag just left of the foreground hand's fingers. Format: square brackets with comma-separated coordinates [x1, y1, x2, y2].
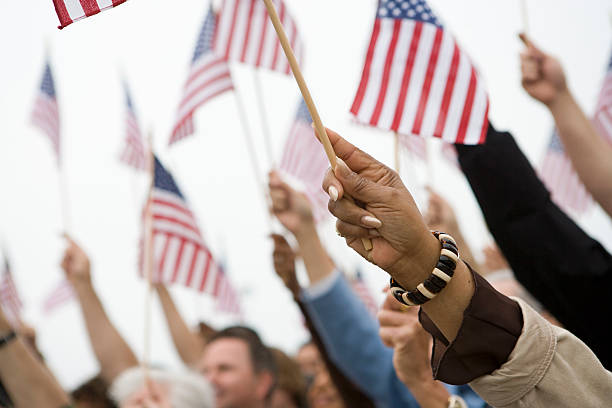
[279, 99, 329, 225]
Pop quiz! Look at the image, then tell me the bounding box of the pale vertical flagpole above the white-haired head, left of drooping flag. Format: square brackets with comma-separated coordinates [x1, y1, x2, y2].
[140, 132, 155, 383]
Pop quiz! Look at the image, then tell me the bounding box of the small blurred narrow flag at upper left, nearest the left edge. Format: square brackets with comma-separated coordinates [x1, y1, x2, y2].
[31, 61, 60, 163]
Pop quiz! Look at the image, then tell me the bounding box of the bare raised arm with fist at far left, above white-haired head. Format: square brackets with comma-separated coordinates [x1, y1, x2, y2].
[62, 238, 138, 384]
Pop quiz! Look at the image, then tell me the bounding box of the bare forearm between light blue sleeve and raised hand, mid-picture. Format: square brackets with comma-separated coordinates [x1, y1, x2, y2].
[295, 223, 336, 284]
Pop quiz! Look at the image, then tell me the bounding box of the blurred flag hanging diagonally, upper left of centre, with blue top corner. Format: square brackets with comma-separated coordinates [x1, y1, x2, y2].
[169, 6, 234, 144]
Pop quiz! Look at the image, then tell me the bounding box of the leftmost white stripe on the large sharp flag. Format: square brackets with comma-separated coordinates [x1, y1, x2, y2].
[357, 19, 393, 123]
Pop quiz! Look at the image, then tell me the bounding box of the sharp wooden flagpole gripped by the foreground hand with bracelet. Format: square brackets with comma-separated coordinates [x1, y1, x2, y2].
[263, 0, 372, 251]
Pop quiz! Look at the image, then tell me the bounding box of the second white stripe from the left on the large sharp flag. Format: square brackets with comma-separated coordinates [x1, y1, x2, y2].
[378, 21, 416, 129]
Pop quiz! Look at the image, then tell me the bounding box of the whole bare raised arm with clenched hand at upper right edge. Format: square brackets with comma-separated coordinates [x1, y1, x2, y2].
[521, 35, 612, 217]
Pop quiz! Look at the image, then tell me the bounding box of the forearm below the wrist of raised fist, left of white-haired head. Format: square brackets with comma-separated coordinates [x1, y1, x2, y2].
[74, 282, 138, 384]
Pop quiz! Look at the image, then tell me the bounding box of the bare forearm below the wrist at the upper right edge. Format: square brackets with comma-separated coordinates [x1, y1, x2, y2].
[548, 90, 612, 215]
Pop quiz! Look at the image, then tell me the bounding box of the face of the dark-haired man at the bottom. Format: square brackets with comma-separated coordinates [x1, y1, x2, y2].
[198, 338, 269, 408]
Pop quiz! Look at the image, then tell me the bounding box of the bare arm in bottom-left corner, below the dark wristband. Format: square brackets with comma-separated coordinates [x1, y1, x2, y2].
[0, 302, 70, 408]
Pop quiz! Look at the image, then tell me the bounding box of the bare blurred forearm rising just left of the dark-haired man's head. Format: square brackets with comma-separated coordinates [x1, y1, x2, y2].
[155, 285, 204, 367]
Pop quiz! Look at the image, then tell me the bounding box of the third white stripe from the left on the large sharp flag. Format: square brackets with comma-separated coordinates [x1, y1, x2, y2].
[399, 24, 437, 134]
